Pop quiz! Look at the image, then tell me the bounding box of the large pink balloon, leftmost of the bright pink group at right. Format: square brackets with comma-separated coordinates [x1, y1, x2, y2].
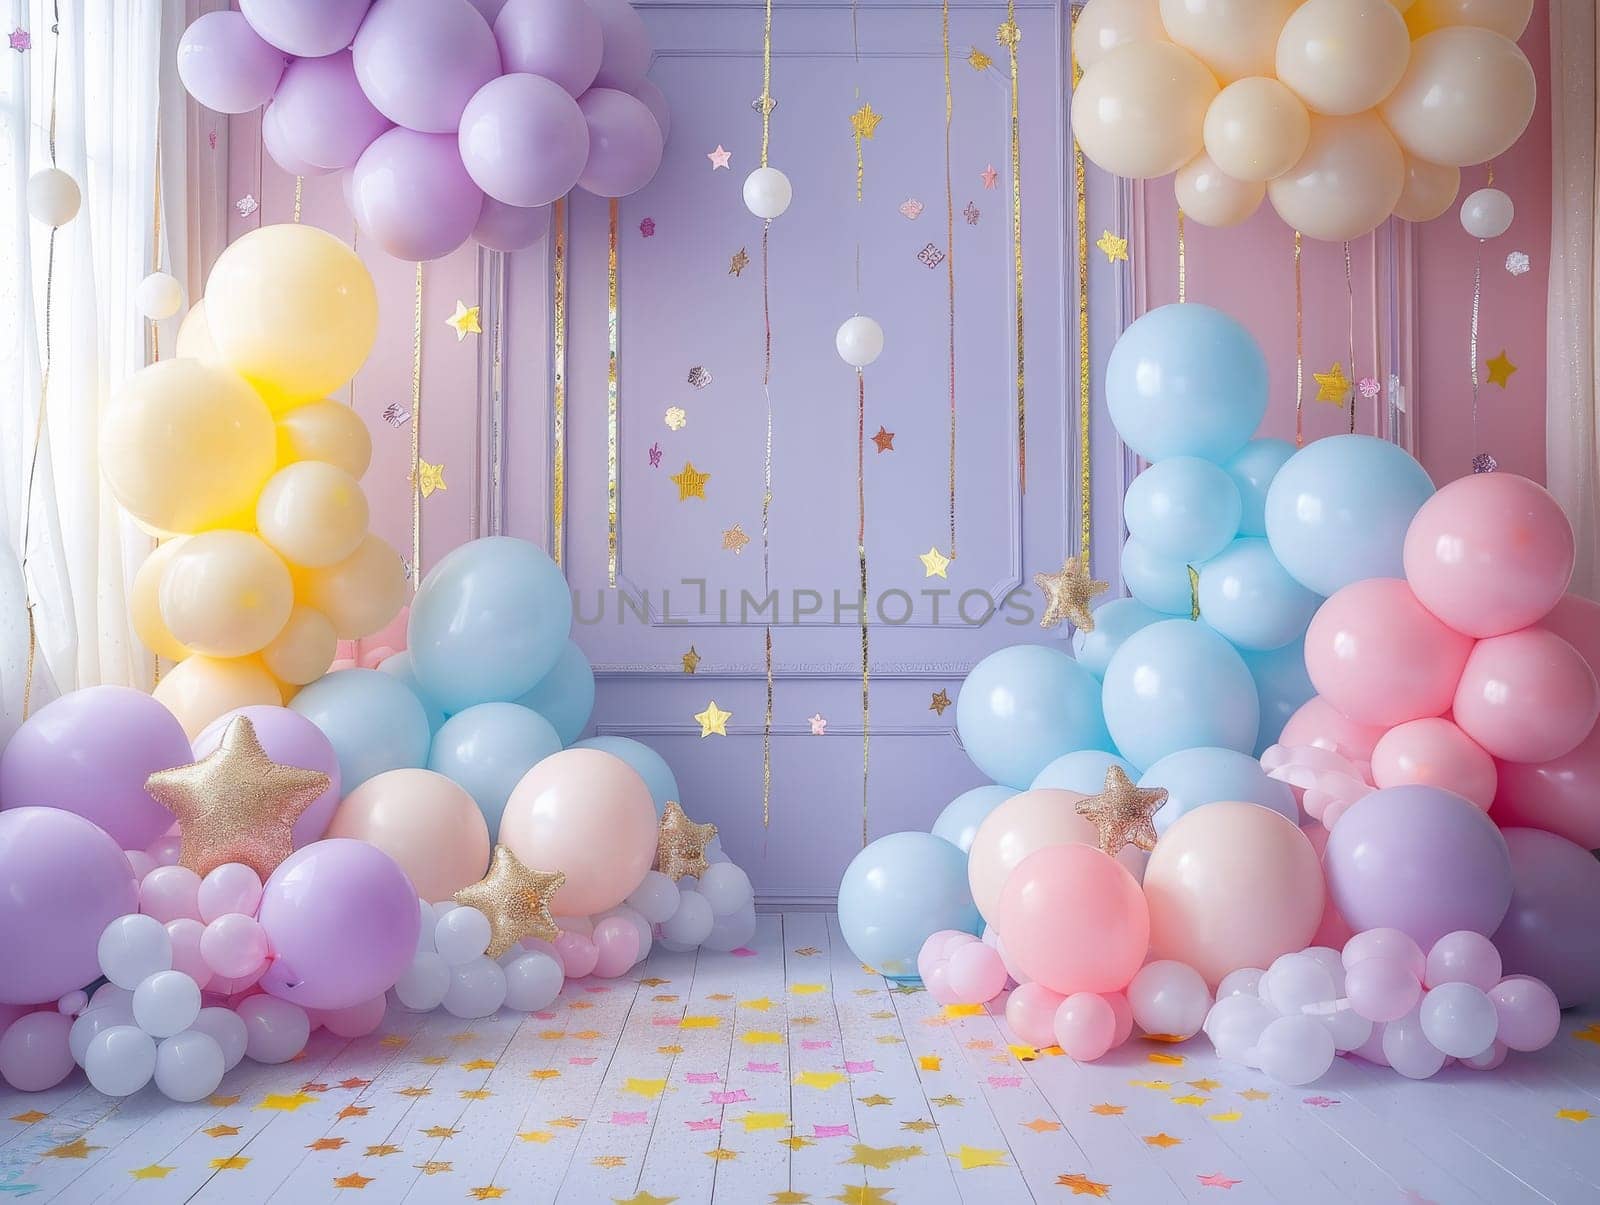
[1299, 578, 1472, 729]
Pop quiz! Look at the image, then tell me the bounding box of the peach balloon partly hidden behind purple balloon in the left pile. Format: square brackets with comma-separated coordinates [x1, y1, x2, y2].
[325, 770, 490, 903]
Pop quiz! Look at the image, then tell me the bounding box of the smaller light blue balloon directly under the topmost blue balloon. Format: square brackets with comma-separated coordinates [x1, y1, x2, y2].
[1122, 456, 1242, 563]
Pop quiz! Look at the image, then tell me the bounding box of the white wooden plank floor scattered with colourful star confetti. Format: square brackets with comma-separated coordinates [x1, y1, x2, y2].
[0, 914, 1600, 1205]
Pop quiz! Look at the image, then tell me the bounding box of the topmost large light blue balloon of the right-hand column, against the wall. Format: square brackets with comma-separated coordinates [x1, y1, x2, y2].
[1106, 302, 1267, 464]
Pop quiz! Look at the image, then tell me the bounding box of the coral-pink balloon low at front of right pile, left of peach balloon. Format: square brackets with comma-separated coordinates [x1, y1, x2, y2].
[979, 838, 1145, 995]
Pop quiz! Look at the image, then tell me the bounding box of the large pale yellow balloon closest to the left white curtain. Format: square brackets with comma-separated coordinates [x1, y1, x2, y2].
[101, 360, 277, 531]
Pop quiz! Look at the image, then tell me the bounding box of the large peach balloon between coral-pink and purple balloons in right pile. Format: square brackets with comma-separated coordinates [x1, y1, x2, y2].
[1144, 802, 1325, 991]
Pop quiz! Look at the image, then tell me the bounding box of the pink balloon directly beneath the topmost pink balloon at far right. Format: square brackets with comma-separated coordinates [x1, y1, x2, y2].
[1454, 627, 1600, 762]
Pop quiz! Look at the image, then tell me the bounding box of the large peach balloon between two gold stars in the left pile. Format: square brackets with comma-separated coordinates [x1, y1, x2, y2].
[499, 749, 656, 915]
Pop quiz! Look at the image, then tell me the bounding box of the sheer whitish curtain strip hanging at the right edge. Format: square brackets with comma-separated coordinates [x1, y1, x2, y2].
[1544, 0, 1600, 598]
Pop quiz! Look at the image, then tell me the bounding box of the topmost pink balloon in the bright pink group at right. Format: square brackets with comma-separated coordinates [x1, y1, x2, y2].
[1405, 472, 1574, 637]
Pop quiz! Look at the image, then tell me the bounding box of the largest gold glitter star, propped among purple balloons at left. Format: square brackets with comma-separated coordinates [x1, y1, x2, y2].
[144, 715, 328, 879]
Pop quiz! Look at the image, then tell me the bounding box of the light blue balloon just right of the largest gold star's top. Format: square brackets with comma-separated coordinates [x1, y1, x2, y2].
[290, 669, 432, 794]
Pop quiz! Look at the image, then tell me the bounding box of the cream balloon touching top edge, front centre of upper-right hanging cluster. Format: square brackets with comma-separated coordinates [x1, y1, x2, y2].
[1275, 0, 1411, 117]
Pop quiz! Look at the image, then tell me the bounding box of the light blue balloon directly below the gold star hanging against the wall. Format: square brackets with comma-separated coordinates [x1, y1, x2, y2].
[955, 645, 1112, 791]
